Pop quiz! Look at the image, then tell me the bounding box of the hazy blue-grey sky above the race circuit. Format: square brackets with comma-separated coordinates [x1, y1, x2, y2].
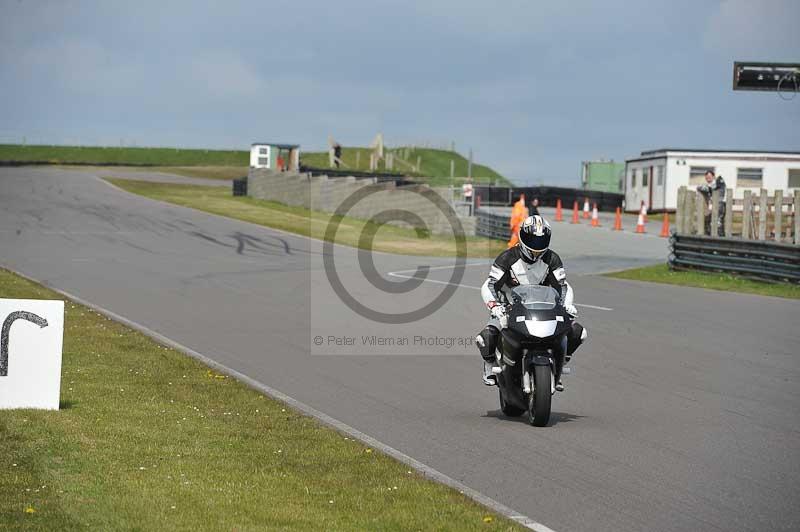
[0, 0, 800, 185]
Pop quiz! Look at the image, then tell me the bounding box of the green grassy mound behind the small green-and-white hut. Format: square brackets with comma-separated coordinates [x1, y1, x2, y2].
[300, 147, 511, 186]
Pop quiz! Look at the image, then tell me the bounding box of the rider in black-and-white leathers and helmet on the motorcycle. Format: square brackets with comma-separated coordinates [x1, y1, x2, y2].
[475, 214, 588, 392]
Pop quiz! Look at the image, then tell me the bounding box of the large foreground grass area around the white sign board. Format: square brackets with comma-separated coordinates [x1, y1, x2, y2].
[0, 270, 515, 530]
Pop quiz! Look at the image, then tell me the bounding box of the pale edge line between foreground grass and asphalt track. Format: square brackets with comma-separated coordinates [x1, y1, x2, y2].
[0, 262, 555, 532]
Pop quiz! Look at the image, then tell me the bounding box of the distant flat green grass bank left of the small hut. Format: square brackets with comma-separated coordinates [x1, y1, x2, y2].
[0, 144, 250, 168]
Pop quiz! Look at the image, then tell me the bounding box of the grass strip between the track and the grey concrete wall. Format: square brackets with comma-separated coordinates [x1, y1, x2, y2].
[109, 179, 505, 258]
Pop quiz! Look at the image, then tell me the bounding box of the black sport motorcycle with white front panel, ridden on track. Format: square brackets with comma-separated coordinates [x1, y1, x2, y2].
[493, 285, 572, 427]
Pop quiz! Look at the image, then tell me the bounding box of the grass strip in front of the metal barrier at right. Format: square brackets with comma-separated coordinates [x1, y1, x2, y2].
[606, 264, 800, 299]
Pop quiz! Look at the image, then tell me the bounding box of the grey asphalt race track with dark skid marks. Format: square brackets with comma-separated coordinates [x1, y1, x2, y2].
[0, 168, 800, 531]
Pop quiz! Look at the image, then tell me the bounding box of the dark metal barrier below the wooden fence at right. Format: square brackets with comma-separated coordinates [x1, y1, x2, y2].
[669, 233, 800, 283]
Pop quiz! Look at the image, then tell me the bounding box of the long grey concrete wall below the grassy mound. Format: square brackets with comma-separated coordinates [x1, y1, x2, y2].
[247, 169, 475, 235]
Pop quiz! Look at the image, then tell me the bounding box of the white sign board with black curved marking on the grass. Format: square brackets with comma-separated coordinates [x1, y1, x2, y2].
[0, 299, 64, 410]
